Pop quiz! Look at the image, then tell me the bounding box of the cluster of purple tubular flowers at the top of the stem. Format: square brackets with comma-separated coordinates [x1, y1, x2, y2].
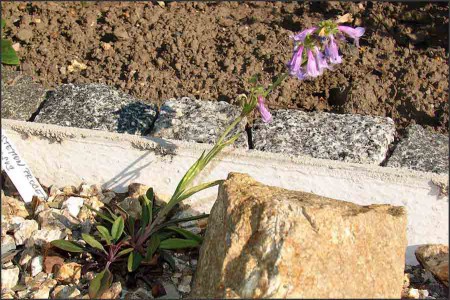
[288, 20, 365, 80]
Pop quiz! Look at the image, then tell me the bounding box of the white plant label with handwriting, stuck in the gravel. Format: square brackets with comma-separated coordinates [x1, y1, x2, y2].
[2, 130, 48, 202]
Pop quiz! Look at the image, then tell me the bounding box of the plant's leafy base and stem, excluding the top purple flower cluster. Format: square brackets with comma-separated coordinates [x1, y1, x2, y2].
[51, 74, 281, 298]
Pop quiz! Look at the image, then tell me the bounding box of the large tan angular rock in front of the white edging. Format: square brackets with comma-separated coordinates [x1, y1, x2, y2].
[190, 173, 407, 298]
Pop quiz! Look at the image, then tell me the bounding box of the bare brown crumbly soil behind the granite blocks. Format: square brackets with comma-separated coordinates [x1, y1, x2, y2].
[2, 1, 448, 133]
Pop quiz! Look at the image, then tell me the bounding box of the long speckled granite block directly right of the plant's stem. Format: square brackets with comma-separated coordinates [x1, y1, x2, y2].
[252, 109, 395, 165]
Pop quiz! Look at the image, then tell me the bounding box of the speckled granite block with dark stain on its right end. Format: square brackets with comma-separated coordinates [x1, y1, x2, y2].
[35, 84, 157, 135]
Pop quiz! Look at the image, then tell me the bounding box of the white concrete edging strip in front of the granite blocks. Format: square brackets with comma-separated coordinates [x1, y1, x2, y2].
[2, 119, 449, 264]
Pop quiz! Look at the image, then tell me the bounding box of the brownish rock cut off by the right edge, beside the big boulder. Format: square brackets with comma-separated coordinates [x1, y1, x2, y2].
[415, 244, 448, 286]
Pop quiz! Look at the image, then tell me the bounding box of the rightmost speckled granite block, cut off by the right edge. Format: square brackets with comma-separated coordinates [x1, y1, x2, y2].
[387, 125, 449, 173]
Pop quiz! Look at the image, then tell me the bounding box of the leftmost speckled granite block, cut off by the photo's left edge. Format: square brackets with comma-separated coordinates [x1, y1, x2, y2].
[1, 67, 46, 121]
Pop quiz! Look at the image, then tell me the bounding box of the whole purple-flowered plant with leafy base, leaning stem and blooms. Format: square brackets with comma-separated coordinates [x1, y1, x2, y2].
[51, 12, 364, 298]
